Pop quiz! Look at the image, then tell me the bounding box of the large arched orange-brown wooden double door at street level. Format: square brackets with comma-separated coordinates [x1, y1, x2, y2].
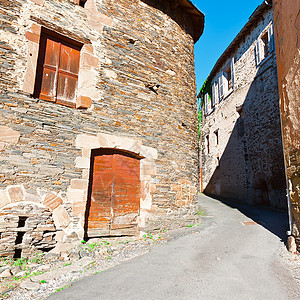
[87, 150, 140, 237]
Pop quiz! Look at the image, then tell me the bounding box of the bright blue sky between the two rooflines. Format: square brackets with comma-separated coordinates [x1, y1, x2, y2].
[192, 0, 263, 93]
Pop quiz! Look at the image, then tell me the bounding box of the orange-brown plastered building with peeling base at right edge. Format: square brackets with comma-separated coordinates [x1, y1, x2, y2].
[273, 0, 300, 252]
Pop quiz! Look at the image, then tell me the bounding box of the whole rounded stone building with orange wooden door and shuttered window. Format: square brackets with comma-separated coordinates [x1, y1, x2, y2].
[0, 0, 204, 257]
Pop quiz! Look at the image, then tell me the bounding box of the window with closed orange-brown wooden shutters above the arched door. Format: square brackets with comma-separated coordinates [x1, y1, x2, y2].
[35, 32, 81, 107]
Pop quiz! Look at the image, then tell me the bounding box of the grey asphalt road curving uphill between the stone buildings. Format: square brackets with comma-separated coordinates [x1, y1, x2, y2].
[49, 195, 300, 300]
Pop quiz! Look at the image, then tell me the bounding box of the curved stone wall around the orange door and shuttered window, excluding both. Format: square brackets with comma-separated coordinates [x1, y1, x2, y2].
[0, 0, 202, 255]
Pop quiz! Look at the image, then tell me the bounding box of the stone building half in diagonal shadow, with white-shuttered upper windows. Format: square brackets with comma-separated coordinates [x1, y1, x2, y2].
[199, 2, 286, 209]
